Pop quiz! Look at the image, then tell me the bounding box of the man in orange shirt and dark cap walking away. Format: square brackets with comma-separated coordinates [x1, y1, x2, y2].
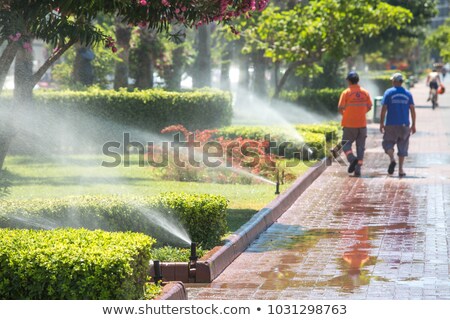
[338, 71, 372, 177]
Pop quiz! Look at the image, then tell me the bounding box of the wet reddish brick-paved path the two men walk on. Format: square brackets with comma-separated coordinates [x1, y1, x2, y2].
[188, 78, 450, 299]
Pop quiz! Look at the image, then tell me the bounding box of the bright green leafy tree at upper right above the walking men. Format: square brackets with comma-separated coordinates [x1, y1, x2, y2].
[244, 0, 412, 98]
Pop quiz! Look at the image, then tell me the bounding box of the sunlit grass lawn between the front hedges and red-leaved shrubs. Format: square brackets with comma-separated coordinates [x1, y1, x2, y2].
[5, 155, 308, 232]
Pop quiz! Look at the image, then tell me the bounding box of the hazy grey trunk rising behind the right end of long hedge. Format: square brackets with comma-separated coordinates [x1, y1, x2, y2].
[192, 25, 211, 88]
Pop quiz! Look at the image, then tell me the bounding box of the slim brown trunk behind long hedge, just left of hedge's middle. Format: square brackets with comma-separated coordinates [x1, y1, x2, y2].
[114, 20, 131, 90]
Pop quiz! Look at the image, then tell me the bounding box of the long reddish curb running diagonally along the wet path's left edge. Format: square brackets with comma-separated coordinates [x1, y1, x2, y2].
[195, 158, 331, 283]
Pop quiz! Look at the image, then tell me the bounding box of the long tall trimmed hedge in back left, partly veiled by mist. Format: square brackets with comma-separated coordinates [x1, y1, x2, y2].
[35, 89, 232, 132]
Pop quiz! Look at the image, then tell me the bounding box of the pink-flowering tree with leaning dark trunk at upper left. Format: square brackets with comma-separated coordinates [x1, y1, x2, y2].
[0, 0, 268, 170]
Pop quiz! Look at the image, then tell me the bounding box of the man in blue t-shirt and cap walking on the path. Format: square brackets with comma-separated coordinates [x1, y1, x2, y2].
[380, 73, 416, 177]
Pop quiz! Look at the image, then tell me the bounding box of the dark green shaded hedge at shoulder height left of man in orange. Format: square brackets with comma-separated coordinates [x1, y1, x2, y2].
[280, 88, 345, 114]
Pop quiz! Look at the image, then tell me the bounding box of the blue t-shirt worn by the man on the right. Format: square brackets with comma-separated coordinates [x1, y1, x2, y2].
[382, 87, 414, 126]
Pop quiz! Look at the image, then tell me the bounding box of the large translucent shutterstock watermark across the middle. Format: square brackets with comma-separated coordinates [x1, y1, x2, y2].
[102, 133, 345, 168]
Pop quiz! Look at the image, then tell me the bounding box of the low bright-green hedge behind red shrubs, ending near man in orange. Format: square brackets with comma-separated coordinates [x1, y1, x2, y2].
[216, 122, 340, 160]
